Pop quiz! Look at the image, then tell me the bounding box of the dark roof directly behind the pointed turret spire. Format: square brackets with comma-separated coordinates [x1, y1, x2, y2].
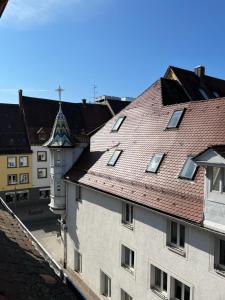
[22, 96, 112, 145]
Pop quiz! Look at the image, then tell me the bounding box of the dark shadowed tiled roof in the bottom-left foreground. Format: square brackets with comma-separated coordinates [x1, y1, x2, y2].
[0, 204, 79, 300]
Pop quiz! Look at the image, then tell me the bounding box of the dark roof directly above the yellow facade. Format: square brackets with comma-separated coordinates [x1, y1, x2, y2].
[0, 103, 31, 154]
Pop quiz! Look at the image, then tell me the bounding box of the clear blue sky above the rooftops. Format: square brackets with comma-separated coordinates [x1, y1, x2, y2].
[0, 0, 225, 103]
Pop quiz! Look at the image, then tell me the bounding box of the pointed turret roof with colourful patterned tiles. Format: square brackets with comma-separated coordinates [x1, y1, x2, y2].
[43, 102, 74, 148]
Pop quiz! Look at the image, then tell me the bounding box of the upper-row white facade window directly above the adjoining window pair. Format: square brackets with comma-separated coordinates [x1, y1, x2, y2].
[168, 221, 185, 251]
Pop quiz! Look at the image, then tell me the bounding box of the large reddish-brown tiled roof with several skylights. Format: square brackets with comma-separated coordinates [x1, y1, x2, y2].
[65, 80, 225, 223]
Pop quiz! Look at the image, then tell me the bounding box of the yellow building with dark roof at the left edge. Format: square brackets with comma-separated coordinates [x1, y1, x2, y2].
[0, 104, 32, 203]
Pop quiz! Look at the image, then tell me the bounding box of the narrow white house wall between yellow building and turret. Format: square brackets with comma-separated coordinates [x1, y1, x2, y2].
[31, 146, 50, 188]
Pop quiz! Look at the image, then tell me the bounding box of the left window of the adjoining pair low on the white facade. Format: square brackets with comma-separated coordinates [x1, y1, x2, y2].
[151, 265, 167, 298]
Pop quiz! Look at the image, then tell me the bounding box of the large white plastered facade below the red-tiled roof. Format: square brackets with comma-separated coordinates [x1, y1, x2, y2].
[67, 183, 225, 300]
